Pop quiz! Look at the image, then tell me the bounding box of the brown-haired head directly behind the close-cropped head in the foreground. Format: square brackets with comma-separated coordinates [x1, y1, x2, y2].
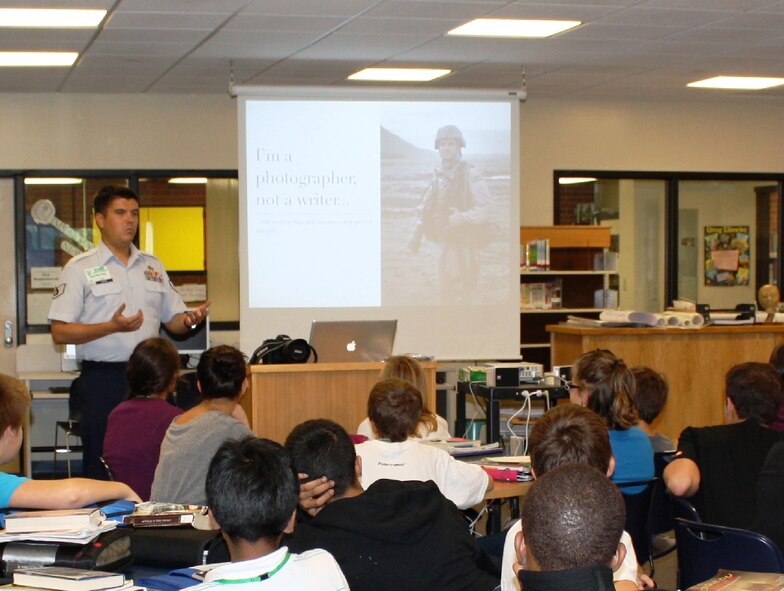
[529, 404, 612, 476]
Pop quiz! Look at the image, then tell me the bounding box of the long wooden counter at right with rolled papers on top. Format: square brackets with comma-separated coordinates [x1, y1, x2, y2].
[547, 324, 784, 443]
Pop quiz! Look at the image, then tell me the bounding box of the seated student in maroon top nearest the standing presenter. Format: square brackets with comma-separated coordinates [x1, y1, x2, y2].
[103, 337, 182, 500]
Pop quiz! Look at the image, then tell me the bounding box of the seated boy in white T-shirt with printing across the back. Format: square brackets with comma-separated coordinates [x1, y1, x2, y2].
[357, 378, 493, 509]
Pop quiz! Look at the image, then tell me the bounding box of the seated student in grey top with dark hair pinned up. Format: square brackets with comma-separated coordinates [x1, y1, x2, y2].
[150, 345, 253, 505]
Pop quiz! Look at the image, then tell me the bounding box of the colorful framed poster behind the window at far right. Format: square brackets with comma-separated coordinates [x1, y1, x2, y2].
[705, 226, 751, 287]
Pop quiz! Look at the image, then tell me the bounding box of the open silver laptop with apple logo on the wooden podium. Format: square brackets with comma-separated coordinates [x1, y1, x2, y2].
[308, 320, 397, 363]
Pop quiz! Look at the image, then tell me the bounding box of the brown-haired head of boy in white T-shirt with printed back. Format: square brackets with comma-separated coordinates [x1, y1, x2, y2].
[368, 378, 422, 441]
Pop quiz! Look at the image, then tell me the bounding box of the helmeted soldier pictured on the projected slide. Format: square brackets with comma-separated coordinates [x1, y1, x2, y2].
[409, 125, 491, 303]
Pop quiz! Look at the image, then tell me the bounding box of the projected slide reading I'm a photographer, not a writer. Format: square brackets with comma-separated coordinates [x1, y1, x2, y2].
[244, 100, 518, 308]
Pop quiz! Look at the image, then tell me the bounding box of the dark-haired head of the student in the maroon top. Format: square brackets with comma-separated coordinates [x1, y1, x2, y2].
[125, 337, 180, 398]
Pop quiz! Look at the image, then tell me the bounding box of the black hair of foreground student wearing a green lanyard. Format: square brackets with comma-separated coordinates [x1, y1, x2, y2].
[205, 435, 299, 542]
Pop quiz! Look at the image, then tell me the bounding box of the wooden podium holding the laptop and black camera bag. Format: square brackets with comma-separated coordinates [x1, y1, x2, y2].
[241, 361, 436, 443]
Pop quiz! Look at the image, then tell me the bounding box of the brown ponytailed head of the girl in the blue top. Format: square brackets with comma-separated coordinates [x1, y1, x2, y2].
[573, 349, 637, 429]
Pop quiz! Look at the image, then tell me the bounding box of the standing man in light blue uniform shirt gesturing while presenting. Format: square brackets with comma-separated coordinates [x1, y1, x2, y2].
[49, 186, 210, 479]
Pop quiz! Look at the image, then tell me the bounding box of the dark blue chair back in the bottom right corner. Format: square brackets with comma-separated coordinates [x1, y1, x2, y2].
[675, 517, 784, 589]
